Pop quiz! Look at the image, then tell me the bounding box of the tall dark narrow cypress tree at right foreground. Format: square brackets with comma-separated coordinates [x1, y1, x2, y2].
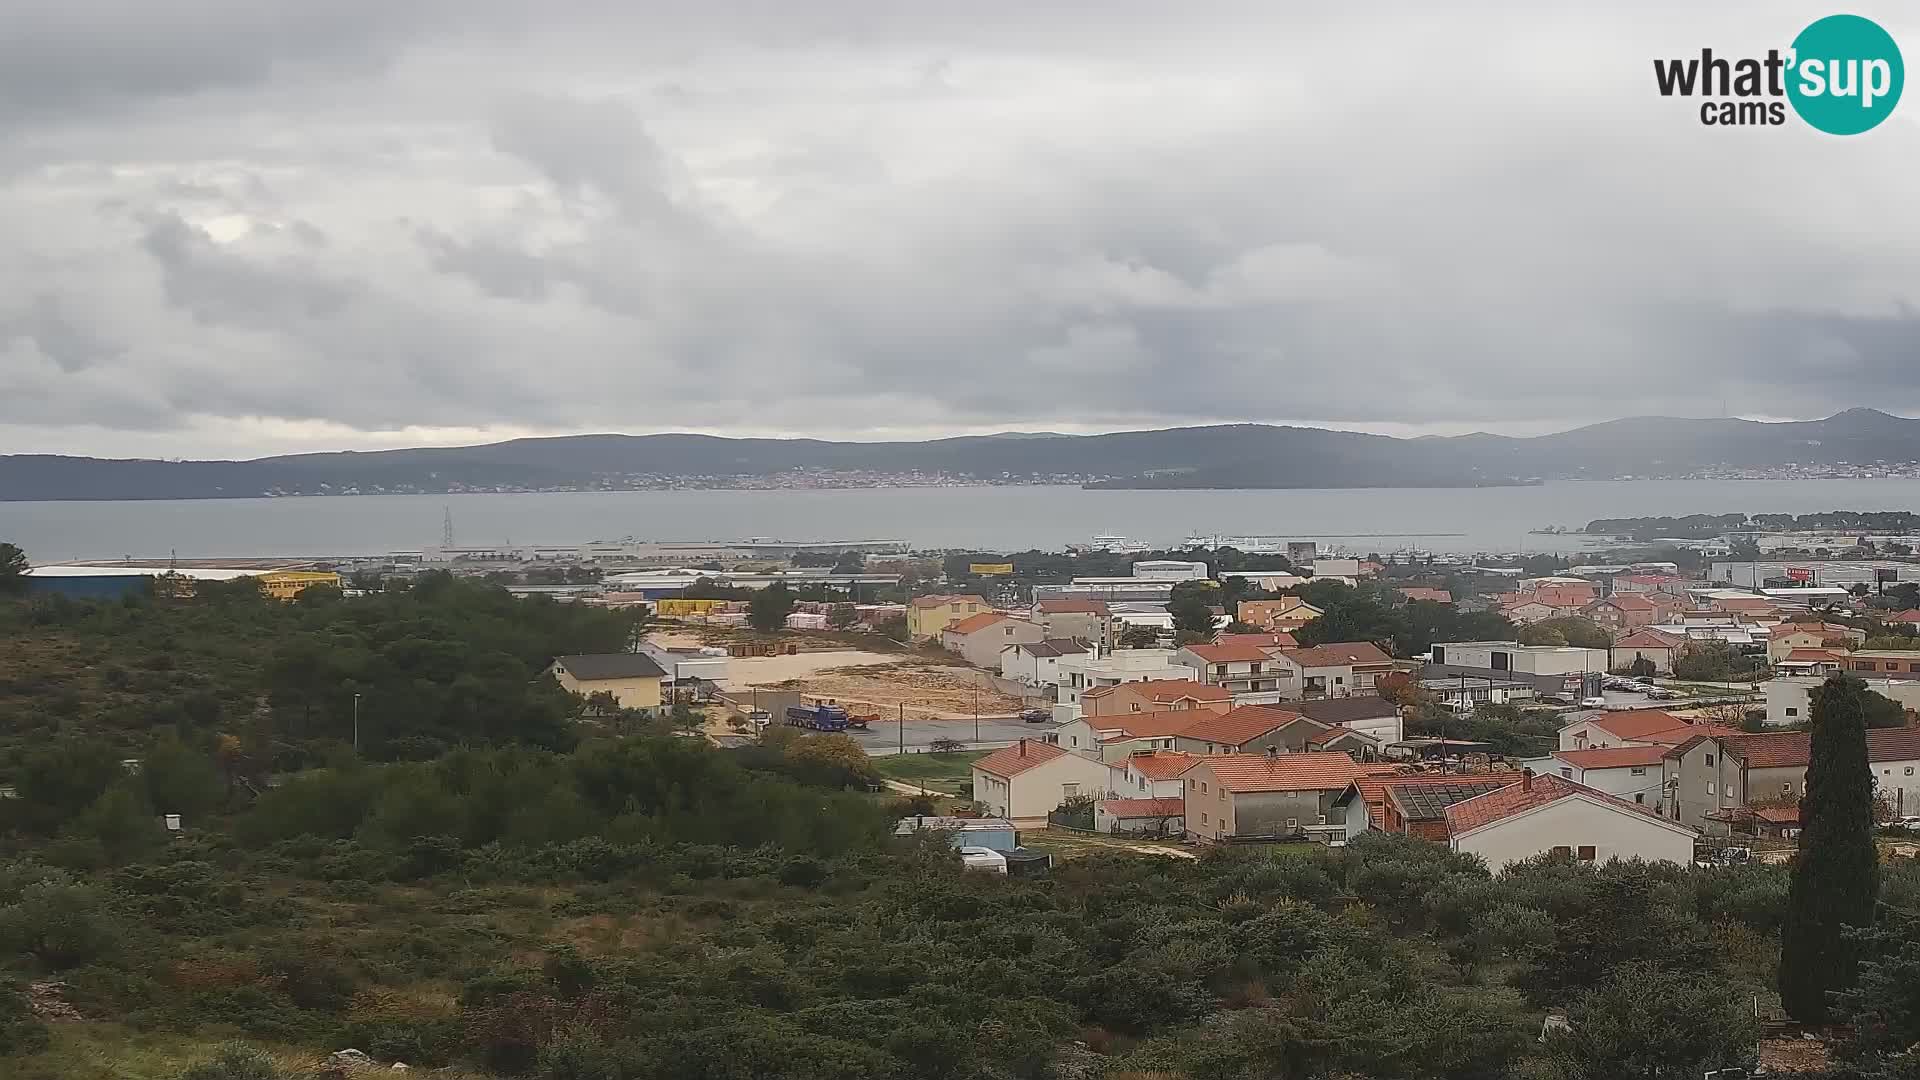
[1780, 675, 1880, 1024]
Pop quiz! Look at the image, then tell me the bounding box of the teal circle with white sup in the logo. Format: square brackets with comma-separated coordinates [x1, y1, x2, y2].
[1788, 15, 1907, 135]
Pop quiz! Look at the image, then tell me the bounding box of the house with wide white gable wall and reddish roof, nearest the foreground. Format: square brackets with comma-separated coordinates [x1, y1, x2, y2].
[1446, 773, 1697, 874]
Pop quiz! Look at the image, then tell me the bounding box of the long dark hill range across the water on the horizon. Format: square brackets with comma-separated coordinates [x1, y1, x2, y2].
[0, 409, 1920, 502]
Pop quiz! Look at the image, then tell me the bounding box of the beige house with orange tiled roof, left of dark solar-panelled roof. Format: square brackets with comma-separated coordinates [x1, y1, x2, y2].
[1185, 753, 1377, 844]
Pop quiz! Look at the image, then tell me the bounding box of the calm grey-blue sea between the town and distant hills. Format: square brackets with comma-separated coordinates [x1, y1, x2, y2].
[11, 479, 1920, 563]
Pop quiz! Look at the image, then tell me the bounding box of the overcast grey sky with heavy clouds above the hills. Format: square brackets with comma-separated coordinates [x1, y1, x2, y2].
[0, 0, 1920, 455]
